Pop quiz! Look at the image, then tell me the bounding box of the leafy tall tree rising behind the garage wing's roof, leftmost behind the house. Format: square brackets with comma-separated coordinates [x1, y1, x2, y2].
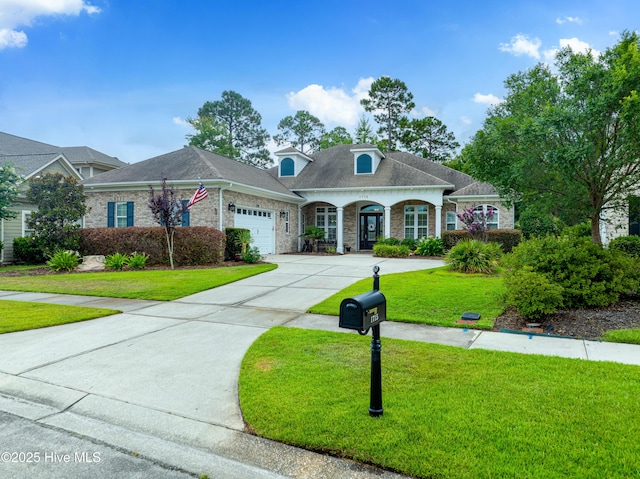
[187, 90, 271, 168]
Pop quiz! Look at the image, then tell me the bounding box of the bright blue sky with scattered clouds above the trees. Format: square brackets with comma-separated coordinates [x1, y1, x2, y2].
[0, 0, 640, 163]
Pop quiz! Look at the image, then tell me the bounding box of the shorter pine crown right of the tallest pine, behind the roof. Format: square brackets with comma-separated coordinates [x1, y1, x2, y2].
[400, 116, 460, 163]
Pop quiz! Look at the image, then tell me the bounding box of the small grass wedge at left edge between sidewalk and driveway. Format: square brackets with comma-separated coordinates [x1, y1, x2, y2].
[0, 300, 120, 334]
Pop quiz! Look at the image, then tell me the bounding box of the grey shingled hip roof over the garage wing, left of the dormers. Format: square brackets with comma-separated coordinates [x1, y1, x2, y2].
[82, 146, 299, 199]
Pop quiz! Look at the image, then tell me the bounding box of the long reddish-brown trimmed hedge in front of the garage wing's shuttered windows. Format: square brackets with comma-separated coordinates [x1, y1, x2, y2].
[80, 226, 226, 266]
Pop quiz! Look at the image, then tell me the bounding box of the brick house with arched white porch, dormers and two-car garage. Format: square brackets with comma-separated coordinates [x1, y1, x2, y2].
[82, 144, 514, 254]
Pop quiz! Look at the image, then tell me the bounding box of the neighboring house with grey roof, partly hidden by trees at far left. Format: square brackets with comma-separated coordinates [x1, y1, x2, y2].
[0, 132, 126, 263]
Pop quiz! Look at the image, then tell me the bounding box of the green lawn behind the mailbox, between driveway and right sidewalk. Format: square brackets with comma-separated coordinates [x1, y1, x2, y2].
[309, 267, 505, 329]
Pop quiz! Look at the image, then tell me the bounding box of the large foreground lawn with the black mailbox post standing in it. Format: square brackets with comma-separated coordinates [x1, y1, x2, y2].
[239, 325, 640, 479]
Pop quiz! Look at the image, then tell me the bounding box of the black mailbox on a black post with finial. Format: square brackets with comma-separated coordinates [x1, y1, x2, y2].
[339, 265, 387, 417]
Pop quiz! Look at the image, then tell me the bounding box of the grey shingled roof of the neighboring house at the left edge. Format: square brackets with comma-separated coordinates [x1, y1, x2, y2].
[0, 132, 126, 176]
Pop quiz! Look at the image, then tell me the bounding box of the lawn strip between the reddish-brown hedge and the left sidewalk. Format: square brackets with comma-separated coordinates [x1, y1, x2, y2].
[0, 264, 277, 301]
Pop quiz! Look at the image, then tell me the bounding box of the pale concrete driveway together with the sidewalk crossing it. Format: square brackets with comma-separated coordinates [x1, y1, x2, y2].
[0, 254, 640, 479]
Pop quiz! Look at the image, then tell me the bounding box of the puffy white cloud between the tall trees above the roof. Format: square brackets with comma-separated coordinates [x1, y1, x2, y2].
[287, 78, 373, 129]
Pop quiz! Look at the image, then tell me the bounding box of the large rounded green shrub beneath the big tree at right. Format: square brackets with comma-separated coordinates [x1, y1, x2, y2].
[503, 236, 632, 308]
